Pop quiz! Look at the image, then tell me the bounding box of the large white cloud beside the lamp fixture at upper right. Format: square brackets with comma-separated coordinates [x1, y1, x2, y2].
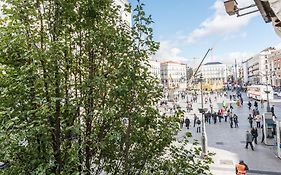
[186, 0, 257, 44]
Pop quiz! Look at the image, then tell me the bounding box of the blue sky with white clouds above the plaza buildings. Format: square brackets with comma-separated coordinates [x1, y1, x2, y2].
[129, 0, 281, 67]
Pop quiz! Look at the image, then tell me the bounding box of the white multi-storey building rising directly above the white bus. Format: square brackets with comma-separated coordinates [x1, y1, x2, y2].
[242, 47, 276, 84]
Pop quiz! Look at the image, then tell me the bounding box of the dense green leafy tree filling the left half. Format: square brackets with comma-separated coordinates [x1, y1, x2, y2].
[0, 0, 209, 175]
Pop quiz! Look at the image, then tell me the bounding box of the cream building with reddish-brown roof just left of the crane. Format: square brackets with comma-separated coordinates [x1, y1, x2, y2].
[161, 61, 187, 90]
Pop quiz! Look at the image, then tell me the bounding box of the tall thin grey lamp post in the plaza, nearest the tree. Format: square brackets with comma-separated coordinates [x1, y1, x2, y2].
[199, 74, 207, 157]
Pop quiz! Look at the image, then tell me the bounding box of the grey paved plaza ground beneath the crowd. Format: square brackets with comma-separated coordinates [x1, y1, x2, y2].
[172, 94, 281, 175]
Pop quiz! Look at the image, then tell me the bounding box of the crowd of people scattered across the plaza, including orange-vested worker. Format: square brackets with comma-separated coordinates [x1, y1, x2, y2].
[171, 88, 276, 173]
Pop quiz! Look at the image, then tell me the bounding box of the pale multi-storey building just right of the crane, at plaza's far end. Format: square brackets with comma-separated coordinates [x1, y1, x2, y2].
[201, 62, 227, 85]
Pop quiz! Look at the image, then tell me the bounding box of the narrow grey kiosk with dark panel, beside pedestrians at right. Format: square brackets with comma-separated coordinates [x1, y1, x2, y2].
[263, 112, 275, 146]
